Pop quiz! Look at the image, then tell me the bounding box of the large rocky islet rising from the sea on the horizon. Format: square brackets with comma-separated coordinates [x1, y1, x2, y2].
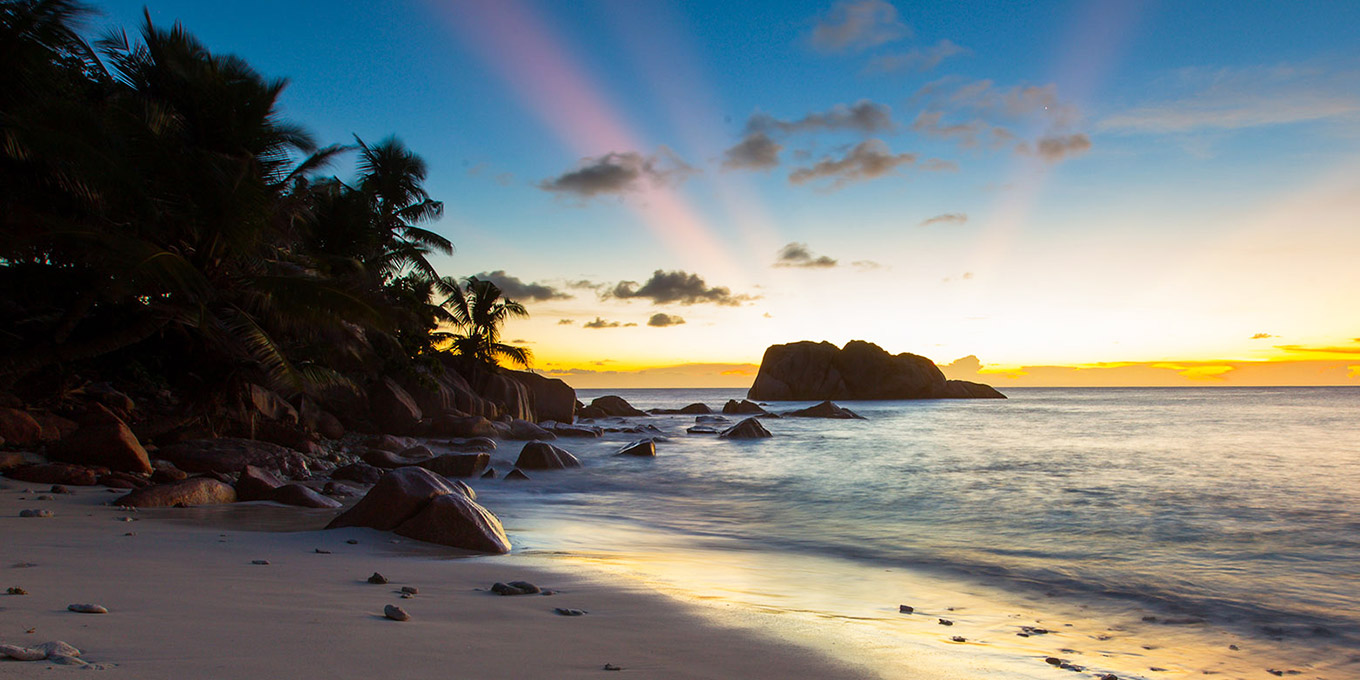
[747, 340, 1005, 401]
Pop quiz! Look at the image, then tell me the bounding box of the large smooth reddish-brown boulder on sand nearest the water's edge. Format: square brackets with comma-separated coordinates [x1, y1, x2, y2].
[326, 468, 510, 552]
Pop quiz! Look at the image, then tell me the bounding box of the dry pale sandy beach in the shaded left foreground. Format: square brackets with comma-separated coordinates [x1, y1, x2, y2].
[0, 480, 873, 680]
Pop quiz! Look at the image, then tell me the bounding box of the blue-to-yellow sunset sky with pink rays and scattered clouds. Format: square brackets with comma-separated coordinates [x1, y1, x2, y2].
[91, 0, 1360, 388]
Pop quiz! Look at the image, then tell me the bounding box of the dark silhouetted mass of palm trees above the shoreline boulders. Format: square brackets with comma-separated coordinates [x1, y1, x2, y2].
[0, 0, 529, 413]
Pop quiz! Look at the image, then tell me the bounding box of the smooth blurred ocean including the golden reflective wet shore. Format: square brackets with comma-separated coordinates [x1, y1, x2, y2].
[473, 388, 1360, 680]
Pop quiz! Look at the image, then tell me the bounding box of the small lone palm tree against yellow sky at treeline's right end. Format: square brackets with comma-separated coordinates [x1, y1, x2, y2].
[443, 276, 533, 369]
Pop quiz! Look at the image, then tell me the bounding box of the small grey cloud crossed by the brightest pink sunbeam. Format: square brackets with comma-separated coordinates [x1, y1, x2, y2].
[539, 147, 698, 199]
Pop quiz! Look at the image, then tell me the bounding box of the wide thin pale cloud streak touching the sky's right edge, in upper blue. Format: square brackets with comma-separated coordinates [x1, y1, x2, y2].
[1098, 64, 1360, 135]
